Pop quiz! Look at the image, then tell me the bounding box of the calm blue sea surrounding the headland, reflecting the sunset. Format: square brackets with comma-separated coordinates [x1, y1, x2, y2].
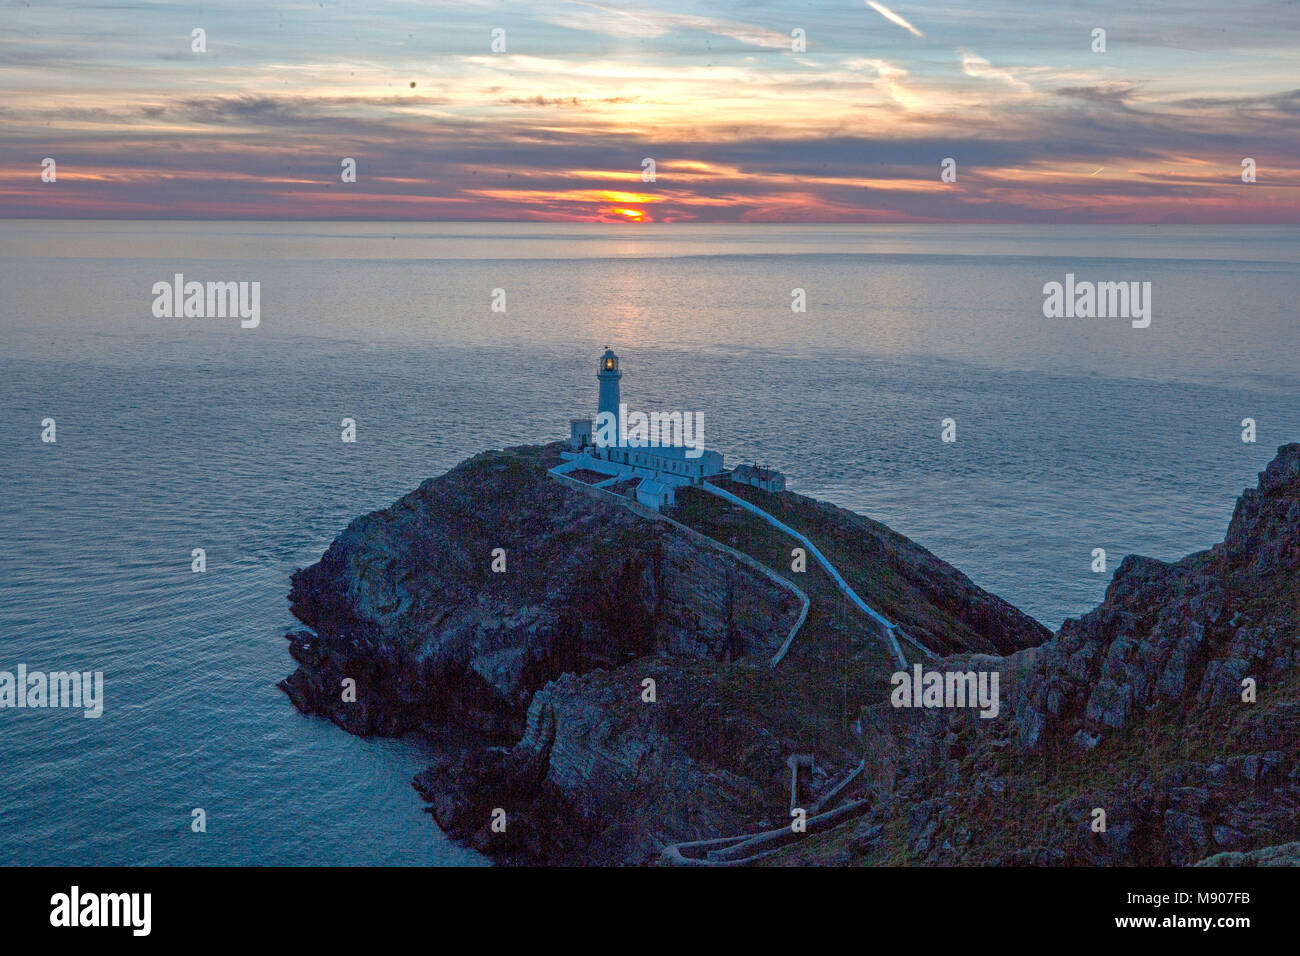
[0, 221, 1300, 864]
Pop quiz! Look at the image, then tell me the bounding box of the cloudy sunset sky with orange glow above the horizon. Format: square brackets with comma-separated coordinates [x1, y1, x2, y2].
[0, 0, 1300, 224]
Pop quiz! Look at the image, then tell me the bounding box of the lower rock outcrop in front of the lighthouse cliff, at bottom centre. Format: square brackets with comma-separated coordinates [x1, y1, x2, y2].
[416, 659, 785, 865]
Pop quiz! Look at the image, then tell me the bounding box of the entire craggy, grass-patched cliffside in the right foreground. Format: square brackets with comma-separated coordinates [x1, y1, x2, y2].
[894, 445, 1300, 865]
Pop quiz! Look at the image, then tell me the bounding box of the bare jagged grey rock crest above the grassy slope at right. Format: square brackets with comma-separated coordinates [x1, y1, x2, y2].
[1013, 445, 1300, 748]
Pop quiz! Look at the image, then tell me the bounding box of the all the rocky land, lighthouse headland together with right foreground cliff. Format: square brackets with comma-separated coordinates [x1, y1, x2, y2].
[281, 445, 1300, 865]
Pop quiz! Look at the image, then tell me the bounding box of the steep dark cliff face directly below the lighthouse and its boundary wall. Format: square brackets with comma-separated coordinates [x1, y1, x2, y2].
[283, 446, 800, 734]
